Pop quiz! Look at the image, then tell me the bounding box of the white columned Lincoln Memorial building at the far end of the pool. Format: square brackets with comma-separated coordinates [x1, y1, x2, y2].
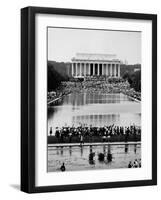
[72, 53, 120, 78]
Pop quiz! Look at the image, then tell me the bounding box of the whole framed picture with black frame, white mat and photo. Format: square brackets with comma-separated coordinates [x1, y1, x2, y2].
[21, 7, 157, 193]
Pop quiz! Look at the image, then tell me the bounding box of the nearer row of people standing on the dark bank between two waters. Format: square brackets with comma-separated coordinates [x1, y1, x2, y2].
[49, 124, 141, 143]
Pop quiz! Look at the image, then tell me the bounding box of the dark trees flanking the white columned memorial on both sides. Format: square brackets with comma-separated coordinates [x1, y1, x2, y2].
[48, 61, 141, 92]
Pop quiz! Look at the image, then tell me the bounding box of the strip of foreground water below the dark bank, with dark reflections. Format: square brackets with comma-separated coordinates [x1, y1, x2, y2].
[48, 144, 141, 171]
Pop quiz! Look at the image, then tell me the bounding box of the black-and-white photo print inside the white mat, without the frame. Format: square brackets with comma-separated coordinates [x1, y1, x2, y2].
[46, 26, 142, 173]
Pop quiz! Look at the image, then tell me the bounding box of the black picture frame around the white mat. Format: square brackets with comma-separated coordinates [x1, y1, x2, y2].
[21, 7, 157, 193]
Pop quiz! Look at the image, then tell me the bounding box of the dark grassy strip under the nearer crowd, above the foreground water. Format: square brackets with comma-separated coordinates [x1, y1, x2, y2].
[48, 135, 141, 144]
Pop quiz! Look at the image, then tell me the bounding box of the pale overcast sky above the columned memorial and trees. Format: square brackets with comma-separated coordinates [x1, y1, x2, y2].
[48, 28, 141, 64]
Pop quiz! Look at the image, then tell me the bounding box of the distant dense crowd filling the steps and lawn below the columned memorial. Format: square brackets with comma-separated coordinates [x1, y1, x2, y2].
[47, 77, 141, 105]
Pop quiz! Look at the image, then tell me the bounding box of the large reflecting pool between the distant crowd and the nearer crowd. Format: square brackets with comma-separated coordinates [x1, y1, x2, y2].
[48, 93, 141, 134]
